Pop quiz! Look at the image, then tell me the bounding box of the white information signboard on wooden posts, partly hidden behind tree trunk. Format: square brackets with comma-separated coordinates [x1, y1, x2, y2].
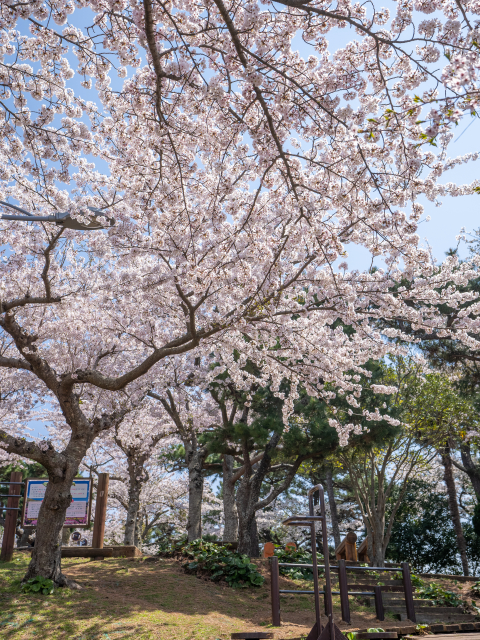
[22, 478, 92, 527]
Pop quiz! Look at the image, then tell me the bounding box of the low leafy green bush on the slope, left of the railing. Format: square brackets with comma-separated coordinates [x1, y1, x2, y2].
[159, 539, 265, 588]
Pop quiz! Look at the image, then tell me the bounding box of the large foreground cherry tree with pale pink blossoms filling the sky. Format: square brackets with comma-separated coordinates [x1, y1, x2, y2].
[0, 0, 478, 584]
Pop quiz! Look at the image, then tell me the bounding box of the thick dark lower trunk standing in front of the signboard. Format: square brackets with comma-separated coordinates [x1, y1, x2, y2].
[23, 472, 78, 587]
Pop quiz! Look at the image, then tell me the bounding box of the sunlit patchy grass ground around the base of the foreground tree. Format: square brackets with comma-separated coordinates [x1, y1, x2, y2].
[0, 554, 394, 640]
